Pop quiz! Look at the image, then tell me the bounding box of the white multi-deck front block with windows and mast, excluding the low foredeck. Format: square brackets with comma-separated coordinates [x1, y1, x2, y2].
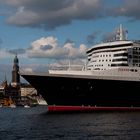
[87, 26, 140, 70]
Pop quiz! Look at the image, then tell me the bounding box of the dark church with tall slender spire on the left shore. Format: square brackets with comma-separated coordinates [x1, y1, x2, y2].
[0, 55, 21, 106]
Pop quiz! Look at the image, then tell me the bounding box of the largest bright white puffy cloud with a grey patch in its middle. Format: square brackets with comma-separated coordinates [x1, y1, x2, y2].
[27, 37, 67, 58]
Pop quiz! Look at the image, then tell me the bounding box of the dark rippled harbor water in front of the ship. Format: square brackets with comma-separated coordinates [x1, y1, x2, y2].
[0, 106, 140, 140]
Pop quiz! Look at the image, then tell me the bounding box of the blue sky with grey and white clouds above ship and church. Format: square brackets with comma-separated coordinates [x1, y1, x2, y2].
[0, 0, 140, 82]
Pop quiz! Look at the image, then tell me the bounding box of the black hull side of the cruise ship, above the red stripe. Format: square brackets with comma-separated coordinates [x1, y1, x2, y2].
[21, 74, 140, 109]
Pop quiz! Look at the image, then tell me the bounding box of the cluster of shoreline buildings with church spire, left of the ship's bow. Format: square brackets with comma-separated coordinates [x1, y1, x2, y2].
[0, 54, 43, 106]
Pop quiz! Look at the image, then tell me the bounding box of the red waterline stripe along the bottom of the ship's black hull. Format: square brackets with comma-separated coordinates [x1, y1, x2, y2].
[48, 105, 140, 112]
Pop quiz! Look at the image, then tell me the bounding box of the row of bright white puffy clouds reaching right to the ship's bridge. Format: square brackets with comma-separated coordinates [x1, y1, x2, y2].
[27, 36, 86, 59]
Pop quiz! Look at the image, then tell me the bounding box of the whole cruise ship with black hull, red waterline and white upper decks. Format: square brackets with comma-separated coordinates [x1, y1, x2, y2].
[20, 25, 140, 112]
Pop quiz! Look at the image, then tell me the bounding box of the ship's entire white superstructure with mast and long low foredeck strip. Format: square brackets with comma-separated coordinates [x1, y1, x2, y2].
[49, 25, 140, 81]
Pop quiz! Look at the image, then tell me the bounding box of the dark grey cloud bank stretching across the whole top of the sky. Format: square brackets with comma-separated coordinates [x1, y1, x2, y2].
[0, 0, 140, 30]
